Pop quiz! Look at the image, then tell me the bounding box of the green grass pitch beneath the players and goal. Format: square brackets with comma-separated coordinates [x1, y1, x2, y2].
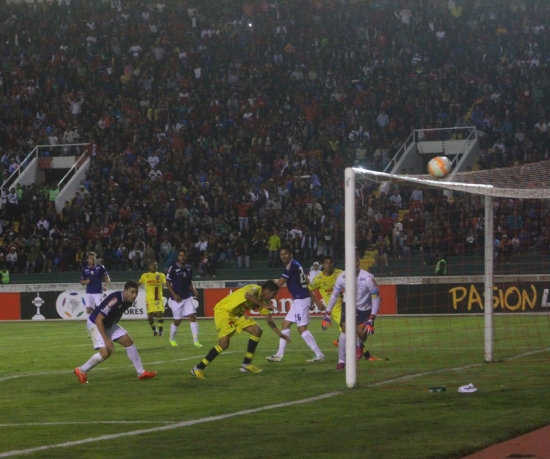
[0, 315, 550, 458]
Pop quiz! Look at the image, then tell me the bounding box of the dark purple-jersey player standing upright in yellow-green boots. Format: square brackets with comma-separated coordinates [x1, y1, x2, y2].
[166, 249, 202, 347]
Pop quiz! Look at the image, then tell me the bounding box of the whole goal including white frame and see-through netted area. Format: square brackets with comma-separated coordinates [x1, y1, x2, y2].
[345, 161, 550, 387]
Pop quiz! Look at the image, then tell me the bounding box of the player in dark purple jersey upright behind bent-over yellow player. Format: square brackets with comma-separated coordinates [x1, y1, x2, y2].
[266, 245, 325, 362]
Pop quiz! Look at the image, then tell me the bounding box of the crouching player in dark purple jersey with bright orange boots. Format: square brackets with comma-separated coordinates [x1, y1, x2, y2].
[74, 281, 157, 384]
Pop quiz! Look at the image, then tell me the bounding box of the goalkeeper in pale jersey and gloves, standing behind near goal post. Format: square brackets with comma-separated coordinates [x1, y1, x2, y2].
[324, 256, 380, 370]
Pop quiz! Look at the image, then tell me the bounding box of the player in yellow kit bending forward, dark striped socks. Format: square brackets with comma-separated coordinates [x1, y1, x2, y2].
[191, 280, 290, 379]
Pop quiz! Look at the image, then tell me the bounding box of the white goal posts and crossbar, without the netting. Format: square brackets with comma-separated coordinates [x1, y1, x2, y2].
[344, 167, 504, 389]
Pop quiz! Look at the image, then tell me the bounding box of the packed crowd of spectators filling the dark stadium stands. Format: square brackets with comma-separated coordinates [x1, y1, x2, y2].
[0, 0, 550, 276]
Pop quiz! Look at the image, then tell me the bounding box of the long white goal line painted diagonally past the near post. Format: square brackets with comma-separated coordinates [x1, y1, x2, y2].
[0, 348, 550, 457]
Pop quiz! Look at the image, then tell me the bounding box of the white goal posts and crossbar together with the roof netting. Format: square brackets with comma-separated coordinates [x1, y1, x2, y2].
[344, 161, 550, 388]
